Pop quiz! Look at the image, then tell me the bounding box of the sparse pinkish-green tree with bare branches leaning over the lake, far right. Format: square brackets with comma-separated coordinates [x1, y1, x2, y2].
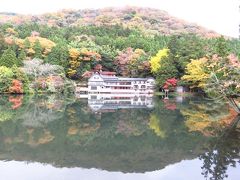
[206, 55, 240, 114]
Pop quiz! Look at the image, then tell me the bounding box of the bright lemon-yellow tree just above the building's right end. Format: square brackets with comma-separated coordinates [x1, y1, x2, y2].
[150, 48, 169, 73]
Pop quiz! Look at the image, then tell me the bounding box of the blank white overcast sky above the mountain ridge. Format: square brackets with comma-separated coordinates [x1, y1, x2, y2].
[0, 0, 240, 37]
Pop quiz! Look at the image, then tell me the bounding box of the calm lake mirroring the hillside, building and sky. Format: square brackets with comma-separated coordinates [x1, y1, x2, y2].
[0, 94, 240, 180]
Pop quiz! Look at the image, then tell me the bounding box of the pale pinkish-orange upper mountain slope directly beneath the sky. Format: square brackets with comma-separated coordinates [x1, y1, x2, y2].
[0, 7, 219, 37]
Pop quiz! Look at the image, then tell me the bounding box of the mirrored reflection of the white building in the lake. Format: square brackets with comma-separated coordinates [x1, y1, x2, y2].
[80, 94, 153, 112]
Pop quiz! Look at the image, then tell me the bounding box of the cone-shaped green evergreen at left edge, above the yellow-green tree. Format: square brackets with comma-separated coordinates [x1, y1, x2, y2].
[0, 48, 21, 67]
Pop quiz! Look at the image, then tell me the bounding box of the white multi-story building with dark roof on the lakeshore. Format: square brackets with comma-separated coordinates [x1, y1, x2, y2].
[88, 73, 155, 94]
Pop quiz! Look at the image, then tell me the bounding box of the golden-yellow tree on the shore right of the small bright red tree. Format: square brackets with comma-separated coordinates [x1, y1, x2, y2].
[182, 57, 210, 88]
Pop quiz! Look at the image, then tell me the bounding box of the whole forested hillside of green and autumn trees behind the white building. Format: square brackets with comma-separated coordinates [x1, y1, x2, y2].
[0, 7, 240, 93]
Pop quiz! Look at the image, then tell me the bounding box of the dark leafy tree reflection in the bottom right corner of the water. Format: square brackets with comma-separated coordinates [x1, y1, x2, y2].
[199, 116, 240, 180]
